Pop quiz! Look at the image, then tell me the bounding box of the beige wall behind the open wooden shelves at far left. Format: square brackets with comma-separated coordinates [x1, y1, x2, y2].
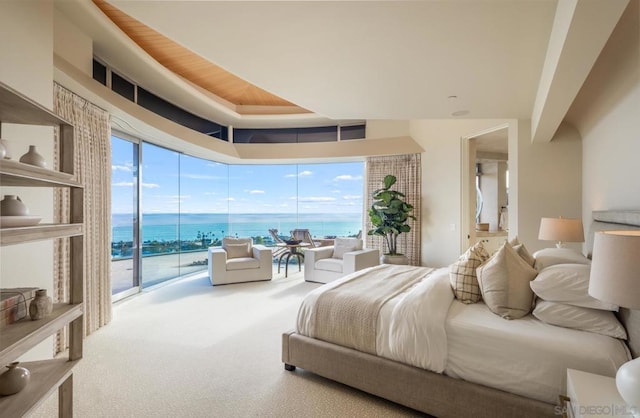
[0, 1, 53, 360]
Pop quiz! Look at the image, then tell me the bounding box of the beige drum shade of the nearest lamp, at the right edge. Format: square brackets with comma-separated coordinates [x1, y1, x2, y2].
[589, 231, 640, 309]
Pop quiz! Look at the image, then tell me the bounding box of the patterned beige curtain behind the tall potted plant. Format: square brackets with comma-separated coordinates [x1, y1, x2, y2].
[364, 154, 422, 266]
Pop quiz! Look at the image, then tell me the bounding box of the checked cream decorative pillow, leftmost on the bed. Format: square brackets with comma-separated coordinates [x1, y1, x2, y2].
[449, 242, 489, 303]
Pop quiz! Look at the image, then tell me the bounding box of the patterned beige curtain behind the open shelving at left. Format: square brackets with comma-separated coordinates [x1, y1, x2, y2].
[54, 84, 111, 353]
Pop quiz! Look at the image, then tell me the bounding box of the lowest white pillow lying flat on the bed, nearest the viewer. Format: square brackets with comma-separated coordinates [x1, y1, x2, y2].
[533, 300, 627, 340]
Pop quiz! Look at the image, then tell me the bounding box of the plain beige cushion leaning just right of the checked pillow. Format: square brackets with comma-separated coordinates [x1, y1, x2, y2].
[476, 242, 538, 319]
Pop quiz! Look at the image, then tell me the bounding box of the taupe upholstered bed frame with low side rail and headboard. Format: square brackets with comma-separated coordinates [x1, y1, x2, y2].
[282, 211, 640, 418]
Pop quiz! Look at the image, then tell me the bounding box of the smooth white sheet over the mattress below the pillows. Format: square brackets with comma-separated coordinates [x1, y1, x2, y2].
[445, 300, 631, 403]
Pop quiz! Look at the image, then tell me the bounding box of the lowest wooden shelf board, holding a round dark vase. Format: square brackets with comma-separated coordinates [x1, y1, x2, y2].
[0, 359, 79, 417]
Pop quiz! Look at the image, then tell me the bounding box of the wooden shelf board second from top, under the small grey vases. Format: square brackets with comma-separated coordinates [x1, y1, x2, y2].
[0, 159, 82, 187]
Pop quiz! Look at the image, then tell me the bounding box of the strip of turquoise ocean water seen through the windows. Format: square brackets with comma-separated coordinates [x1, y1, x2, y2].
[111, 213, 362, 243]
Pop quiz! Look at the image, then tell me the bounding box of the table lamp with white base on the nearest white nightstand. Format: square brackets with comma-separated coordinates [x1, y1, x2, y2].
[589, 231, 640, 417]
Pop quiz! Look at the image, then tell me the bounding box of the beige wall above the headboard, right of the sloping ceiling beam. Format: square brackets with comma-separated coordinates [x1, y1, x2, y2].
[567, 0, 640, 227]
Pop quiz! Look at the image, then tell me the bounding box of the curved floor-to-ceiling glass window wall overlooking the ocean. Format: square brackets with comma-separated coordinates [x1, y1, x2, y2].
[112, 135, 364, 294]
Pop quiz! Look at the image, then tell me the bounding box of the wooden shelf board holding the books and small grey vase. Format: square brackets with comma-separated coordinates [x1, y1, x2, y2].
[0, 303, 82, 365]
